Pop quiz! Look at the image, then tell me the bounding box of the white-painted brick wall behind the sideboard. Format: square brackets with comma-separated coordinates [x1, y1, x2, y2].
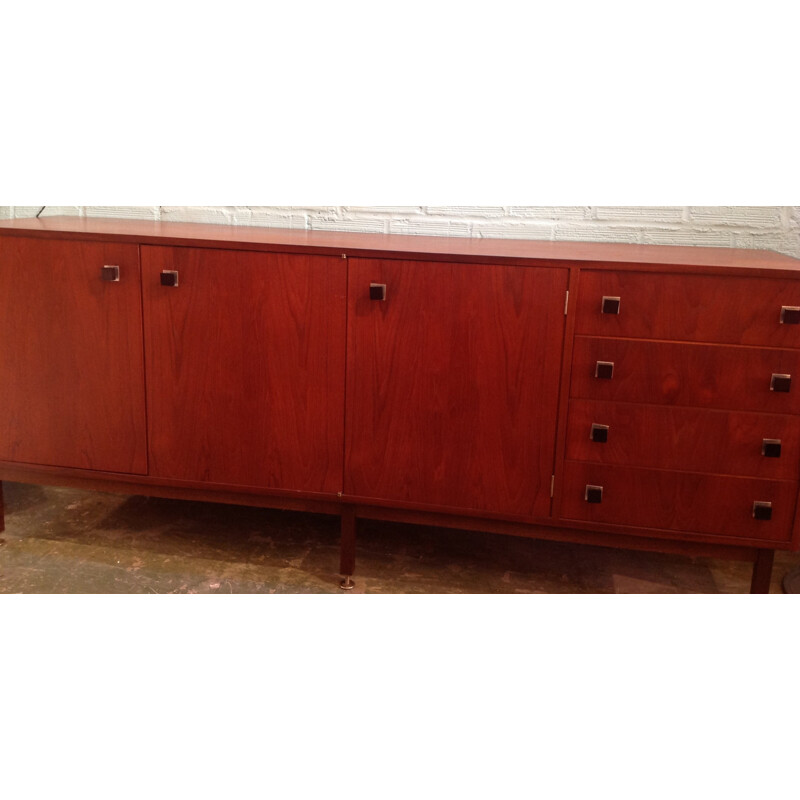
[0, 206, 800, 258]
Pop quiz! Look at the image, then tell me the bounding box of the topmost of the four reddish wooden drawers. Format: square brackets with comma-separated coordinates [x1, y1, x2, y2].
[575, 270, 800, 347]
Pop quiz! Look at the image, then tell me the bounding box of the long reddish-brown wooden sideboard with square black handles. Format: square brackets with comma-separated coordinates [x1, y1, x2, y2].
[0, 217, 800, 592]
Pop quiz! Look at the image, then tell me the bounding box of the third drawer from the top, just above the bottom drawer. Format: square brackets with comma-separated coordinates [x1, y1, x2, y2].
[566, 400, 800, 480]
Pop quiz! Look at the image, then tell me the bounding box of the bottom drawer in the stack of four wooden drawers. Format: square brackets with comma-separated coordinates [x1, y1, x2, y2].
[561, 461, 797, 542]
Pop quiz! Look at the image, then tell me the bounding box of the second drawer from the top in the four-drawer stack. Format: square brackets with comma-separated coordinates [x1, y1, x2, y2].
[570, 336, 800, 414]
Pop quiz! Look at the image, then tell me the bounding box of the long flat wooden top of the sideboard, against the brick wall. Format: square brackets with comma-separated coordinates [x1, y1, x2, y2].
[0, 217, 800, 275]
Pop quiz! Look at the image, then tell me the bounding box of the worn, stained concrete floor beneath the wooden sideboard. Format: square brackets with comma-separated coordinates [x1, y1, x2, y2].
[0, 483, 800, 594]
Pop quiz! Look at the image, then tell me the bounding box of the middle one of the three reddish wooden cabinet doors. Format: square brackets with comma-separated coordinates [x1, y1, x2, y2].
[142, 247, 346, 493]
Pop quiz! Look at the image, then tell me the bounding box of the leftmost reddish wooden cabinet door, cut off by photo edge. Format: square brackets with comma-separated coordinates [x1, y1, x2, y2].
[0, 236, 147, 474]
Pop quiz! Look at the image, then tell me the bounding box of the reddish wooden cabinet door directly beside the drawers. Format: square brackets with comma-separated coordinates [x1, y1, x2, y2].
[345, 259, 567, 518]
